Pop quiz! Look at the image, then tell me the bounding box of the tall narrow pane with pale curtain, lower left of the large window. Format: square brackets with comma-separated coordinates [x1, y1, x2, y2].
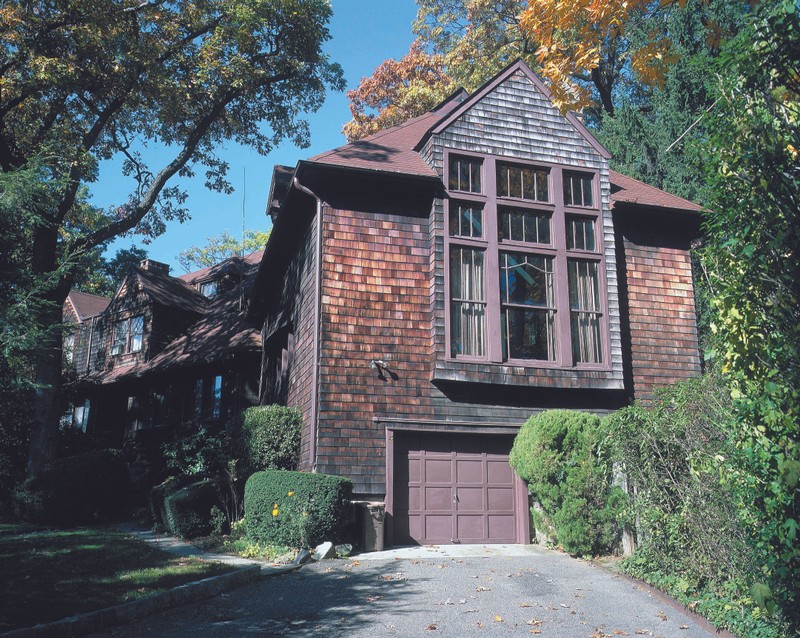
[450, 246, 486, 357]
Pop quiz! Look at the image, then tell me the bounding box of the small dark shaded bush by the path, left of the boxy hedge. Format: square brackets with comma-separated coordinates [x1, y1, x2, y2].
[164, 480, 221, 538]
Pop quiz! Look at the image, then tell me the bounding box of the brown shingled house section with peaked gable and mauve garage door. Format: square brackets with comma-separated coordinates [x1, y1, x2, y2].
[249, 62, 700, 543]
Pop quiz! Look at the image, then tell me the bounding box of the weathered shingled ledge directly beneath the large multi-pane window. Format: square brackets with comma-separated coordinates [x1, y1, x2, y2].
[431, 360, 625, 390]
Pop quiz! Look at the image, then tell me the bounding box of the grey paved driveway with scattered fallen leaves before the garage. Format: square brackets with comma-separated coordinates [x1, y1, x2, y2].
[99, 546, 713, 638]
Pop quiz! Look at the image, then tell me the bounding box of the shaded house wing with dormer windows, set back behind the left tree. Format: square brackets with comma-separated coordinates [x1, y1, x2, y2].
[65, 251, 262, 445]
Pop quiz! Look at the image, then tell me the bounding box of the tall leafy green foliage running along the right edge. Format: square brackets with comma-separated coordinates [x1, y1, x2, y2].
[701, 1, 800, 631]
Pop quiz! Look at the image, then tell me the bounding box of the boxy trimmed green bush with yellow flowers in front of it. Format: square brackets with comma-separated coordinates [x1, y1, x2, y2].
[244, 470, 353, 547]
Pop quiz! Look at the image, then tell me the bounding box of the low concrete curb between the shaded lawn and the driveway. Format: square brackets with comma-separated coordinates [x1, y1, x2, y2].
[0, 565, 262, 638]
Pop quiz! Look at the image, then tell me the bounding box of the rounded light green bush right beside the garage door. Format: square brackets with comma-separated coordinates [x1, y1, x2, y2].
[510, 410, 626, 555]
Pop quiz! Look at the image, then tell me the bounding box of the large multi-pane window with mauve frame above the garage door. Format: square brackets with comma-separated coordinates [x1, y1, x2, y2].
[447, 155, 607, 366]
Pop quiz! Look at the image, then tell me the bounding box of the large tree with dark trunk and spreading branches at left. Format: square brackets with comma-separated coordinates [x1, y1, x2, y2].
[0, 0, 342, 471]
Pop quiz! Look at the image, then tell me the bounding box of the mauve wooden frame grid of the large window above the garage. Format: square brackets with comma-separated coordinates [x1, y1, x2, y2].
[443, 149, 611, 371]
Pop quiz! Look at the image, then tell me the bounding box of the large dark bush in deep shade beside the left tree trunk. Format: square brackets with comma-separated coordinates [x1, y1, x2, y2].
[14, 450, 129, 526]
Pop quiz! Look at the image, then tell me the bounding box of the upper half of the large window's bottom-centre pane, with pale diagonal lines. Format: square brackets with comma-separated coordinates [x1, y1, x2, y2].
[500, 253, 555, 308]
